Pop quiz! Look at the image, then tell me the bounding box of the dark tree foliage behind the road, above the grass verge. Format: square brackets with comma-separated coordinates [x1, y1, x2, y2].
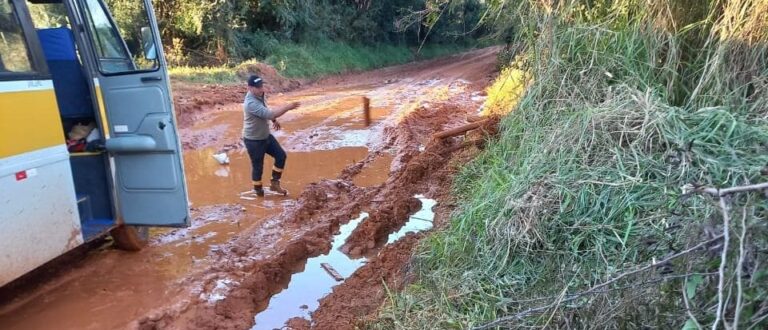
[103, 0, 483, 65]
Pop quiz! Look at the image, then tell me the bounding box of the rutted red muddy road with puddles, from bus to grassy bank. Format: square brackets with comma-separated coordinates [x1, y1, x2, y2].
[0, 48, 498, 329]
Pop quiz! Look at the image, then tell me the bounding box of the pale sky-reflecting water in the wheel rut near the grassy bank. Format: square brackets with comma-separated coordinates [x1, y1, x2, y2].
[251, 195, 437, 330]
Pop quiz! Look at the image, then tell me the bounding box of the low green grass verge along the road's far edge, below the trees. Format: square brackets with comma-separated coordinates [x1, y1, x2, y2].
[169, 41, 469, 84]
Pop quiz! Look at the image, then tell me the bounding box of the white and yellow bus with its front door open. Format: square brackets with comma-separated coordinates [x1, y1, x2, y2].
[0, 0, 189, 286]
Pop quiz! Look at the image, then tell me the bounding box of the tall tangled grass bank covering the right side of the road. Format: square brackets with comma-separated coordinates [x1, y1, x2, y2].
[369, 0, 768, 329]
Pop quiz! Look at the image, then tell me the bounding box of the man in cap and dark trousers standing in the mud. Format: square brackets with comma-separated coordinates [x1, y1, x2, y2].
[243, 75, 299, 197]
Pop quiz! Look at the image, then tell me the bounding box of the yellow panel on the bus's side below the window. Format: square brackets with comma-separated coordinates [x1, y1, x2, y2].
[0, 89, 64, 158]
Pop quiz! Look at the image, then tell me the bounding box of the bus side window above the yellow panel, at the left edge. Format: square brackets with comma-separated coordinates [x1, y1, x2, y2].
[0, 0, 32, 74]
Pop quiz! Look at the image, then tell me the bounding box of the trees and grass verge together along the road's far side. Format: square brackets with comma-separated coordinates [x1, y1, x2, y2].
[107, 0, 494, 83]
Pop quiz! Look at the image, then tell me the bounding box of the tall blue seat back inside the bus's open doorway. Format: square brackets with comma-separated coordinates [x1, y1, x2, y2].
[37, 28, 94, 118]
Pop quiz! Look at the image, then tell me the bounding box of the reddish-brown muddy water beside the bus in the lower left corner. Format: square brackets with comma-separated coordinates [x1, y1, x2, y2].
[0, 205, 242, 330]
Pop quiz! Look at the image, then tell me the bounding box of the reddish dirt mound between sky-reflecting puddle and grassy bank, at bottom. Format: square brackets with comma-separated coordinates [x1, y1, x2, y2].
[308, 233, 422, 330]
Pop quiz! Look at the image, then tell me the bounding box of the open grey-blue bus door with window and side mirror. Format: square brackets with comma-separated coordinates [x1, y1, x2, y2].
[78, 0, 189, 227]
